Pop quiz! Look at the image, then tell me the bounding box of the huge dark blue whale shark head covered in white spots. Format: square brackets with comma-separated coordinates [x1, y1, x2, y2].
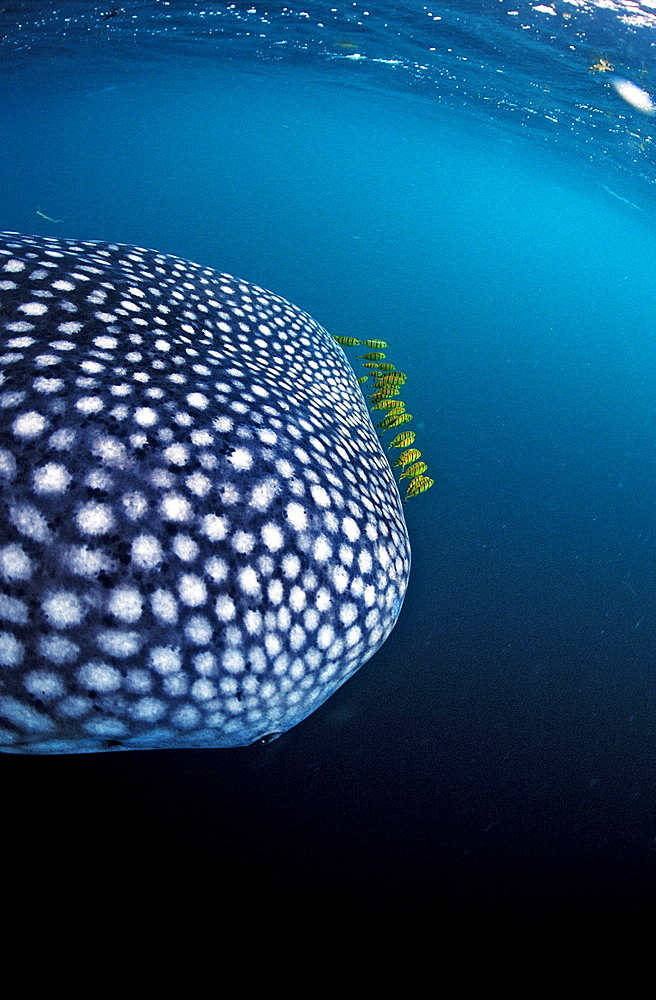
[0, 233, 410, 754]
